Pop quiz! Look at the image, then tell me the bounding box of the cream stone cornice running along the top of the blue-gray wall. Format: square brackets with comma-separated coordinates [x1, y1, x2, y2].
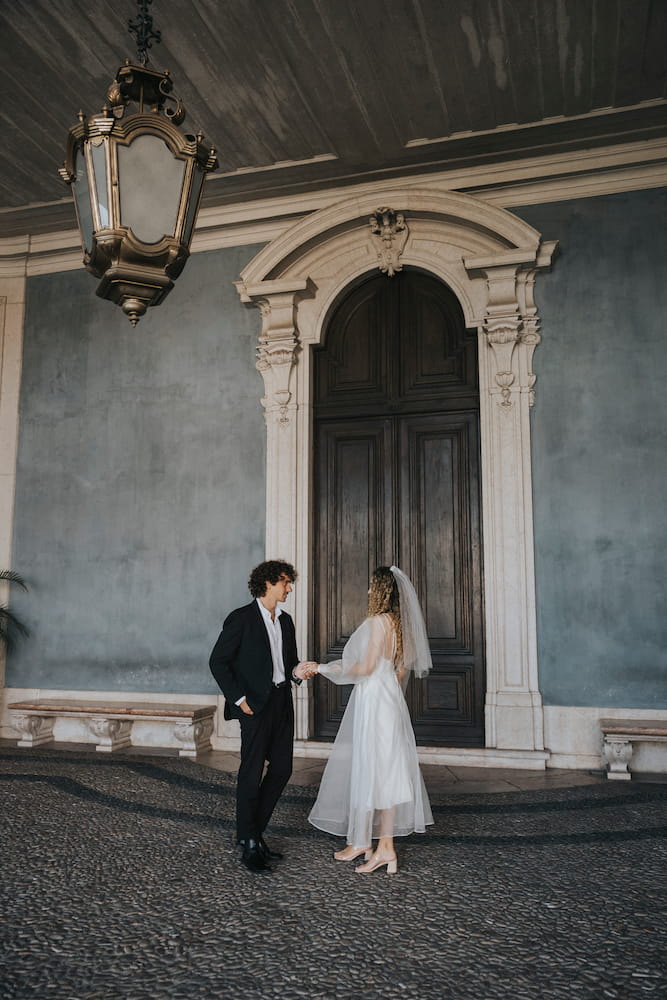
[0, 138, 667, 277]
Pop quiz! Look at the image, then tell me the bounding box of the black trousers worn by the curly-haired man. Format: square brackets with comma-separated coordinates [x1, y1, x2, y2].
[236, 682, 294, 840]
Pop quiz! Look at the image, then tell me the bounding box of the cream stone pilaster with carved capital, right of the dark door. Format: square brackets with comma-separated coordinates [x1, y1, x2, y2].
[465, 247, 553, 750]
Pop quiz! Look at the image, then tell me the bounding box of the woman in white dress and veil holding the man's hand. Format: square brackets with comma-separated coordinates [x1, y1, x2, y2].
[308, 566, 433, 875]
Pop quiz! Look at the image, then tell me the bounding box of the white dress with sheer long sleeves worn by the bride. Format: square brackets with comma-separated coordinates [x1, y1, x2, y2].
[308, 615, 433, 848]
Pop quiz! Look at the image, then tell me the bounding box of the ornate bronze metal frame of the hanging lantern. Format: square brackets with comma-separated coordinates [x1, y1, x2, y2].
[60, 54, 218, 326]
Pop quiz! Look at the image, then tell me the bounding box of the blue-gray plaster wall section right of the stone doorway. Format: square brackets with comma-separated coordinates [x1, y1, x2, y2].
[513, 189, 667, 708]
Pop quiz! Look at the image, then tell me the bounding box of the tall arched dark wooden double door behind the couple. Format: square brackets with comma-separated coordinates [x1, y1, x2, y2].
[312, 270, 485, 746]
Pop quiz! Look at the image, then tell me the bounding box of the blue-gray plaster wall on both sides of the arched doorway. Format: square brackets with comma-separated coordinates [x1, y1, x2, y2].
[6, 190, 667, 708]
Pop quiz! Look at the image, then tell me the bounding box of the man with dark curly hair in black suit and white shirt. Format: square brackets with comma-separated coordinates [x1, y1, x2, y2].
[209, 559, 312, 873]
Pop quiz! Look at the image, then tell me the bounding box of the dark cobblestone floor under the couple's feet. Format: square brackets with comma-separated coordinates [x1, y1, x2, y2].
[0, 749, 667, 1000]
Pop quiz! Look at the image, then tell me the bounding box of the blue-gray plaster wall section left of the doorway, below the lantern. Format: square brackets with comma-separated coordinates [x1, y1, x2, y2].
[6, 247, 265, 693]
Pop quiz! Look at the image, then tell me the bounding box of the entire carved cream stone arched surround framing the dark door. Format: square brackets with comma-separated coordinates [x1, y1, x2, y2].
[237, 188, 556, 767]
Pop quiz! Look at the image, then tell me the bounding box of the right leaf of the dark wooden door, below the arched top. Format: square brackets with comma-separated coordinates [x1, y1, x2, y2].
[399, 413, 484, 745]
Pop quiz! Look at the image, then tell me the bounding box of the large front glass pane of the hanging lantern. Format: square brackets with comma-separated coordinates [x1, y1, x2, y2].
[118, 135, 185, 243]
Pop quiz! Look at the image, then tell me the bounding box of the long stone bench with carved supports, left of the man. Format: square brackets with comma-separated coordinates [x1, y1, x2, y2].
[7, 698, 215, 757]
